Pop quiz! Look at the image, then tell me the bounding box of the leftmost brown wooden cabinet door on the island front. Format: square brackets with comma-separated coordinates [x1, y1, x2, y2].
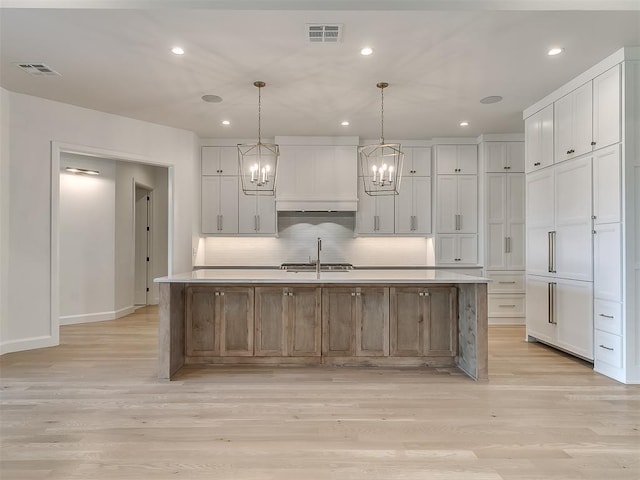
[185, 287, 220, 357]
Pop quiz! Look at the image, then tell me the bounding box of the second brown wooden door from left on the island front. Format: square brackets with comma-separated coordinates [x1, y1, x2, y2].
[216, 287, 254, 356]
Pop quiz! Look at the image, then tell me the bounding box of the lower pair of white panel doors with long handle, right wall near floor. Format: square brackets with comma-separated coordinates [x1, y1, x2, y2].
[526, 275, 593, 360]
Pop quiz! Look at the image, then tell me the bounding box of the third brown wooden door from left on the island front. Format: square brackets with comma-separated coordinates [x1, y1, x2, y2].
[255, 287, 288, 357]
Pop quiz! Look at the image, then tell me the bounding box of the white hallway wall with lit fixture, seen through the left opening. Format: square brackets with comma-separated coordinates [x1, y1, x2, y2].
[58, 154, 116, 325]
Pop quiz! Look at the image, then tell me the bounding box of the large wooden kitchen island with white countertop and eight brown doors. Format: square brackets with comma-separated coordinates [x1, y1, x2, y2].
[156, 269, 488, 380]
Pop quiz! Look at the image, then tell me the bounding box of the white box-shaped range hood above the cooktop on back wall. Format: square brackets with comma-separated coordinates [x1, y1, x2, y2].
[275, 137, 359, 212]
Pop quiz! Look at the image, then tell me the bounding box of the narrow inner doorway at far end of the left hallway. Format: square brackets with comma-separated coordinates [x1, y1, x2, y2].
[134, 183, 153, 306]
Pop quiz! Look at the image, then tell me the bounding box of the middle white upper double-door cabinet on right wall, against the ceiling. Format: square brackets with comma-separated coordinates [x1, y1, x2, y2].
[553, 82, 593, 163]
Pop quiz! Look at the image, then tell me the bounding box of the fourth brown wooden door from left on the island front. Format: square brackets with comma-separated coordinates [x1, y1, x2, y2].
[286, 287, 322, 357]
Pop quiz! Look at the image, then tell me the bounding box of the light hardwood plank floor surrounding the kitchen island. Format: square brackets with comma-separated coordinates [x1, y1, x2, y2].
[0, 307, 640, 480]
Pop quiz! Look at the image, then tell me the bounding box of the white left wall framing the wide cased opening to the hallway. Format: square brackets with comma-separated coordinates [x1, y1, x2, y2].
[0, 91, 199, 353]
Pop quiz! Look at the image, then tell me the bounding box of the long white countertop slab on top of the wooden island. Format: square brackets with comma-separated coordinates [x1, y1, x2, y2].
[154, 268, 490, 284]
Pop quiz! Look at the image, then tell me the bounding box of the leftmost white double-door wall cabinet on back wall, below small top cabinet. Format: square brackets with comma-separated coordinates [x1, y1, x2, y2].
[201, 175, 238, 234]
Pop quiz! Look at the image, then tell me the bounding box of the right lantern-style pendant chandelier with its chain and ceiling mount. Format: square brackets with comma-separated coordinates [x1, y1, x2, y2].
[358, 82, 404, 195]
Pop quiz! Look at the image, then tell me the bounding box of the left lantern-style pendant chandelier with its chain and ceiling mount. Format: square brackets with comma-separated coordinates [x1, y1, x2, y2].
[238, 82, 280, 195]
